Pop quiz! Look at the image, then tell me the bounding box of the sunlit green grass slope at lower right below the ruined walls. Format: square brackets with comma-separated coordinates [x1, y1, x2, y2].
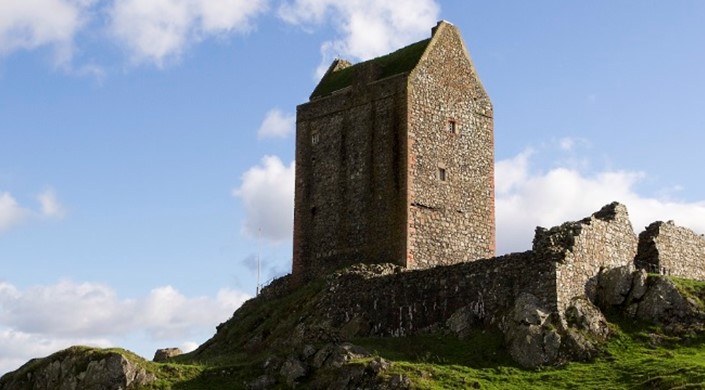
[359, 320, 705, 389]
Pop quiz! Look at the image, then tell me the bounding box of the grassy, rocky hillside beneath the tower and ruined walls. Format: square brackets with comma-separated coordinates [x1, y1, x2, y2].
[0, 275, 705, 390]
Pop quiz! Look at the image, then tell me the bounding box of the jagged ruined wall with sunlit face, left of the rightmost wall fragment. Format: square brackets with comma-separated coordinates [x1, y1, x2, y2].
[533, 203, 637, 311]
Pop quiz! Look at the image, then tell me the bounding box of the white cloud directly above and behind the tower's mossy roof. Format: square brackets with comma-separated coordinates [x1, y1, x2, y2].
[279, 0, 440, 76]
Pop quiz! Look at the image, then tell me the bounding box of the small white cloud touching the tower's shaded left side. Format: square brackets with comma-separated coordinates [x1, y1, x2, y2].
[233, 156, 294, 242]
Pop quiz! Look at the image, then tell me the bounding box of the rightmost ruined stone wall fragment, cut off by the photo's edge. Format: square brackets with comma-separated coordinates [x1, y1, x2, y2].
[634, 221, 705, 280]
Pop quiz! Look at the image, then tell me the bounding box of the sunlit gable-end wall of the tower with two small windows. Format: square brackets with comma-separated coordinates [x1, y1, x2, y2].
[407, 23, 495, 268]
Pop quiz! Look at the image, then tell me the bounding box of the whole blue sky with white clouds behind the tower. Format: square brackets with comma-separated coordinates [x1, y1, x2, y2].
[0, 0, 705, 372]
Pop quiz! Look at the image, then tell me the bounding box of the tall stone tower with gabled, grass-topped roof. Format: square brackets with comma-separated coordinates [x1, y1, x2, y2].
[293, 21, 495, 281]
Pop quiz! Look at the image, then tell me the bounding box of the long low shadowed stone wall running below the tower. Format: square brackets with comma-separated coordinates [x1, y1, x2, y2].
[321, 252, 556, 337]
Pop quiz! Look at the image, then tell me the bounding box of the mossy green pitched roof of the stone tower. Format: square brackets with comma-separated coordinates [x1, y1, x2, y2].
[311, 38, 431, 99]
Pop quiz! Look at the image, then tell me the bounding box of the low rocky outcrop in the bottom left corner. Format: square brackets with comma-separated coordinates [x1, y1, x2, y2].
[0, 347, 156, 390]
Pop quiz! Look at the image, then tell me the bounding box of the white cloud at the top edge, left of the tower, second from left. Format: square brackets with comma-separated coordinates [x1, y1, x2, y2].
[110, 0, 267, 66]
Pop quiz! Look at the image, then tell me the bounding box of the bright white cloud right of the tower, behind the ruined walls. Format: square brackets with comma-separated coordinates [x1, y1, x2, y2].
[496, 145, 705, 253]
